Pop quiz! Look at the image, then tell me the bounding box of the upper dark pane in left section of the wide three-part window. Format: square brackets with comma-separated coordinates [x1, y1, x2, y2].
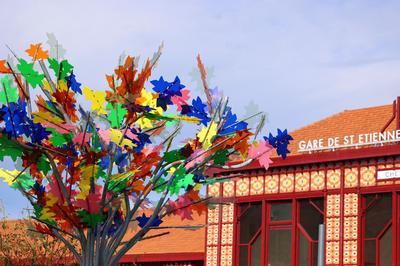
[240, 202, 262, 244]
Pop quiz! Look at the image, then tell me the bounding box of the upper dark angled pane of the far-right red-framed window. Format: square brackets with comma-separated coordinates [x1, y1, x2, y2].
[365, 194, 392, 238]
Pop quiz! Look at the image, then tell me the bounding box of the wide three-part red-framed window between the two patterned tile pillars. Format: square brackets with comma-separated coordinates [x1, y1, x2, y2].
[237, 198, 324, 266]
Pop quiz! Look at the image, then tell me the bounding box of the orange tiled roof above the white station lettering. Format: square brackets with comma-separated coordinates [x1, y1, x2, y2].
[289, 104, 396, 155]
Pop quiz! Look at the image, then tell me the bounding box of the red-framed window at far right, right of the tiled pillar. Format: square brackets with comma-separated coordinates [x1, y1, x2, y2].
[363, 193, 393, 266]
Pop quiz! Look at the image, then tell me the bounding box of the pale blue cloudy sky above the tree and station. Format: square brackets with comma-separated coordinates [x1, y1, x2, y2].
[0, 0, 400, 216]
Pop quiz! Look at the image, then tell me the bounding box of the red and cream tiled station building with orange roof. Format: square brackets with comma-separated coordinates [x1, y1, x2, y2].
[205, 99, 400, 266]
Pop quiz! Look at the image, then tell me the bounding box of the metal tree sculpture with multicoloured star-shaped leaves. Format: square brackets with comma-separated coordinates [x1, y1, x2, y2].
[0, 40, 290, 265]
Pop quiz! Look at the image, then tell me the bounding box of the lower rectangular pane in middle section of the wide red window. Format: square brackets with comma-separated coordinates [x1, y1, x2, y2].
[268, 229, 292, 266]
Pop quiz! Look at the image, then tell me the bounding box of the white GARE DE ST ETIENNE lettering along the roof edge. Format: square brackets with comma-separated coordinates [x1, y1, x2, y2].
[298, 129, 400, 152]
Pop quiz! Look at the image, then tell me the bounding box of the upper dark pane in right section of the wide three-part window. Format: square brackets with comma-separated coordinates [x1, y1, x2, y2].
[300, 199, 324, 241]
